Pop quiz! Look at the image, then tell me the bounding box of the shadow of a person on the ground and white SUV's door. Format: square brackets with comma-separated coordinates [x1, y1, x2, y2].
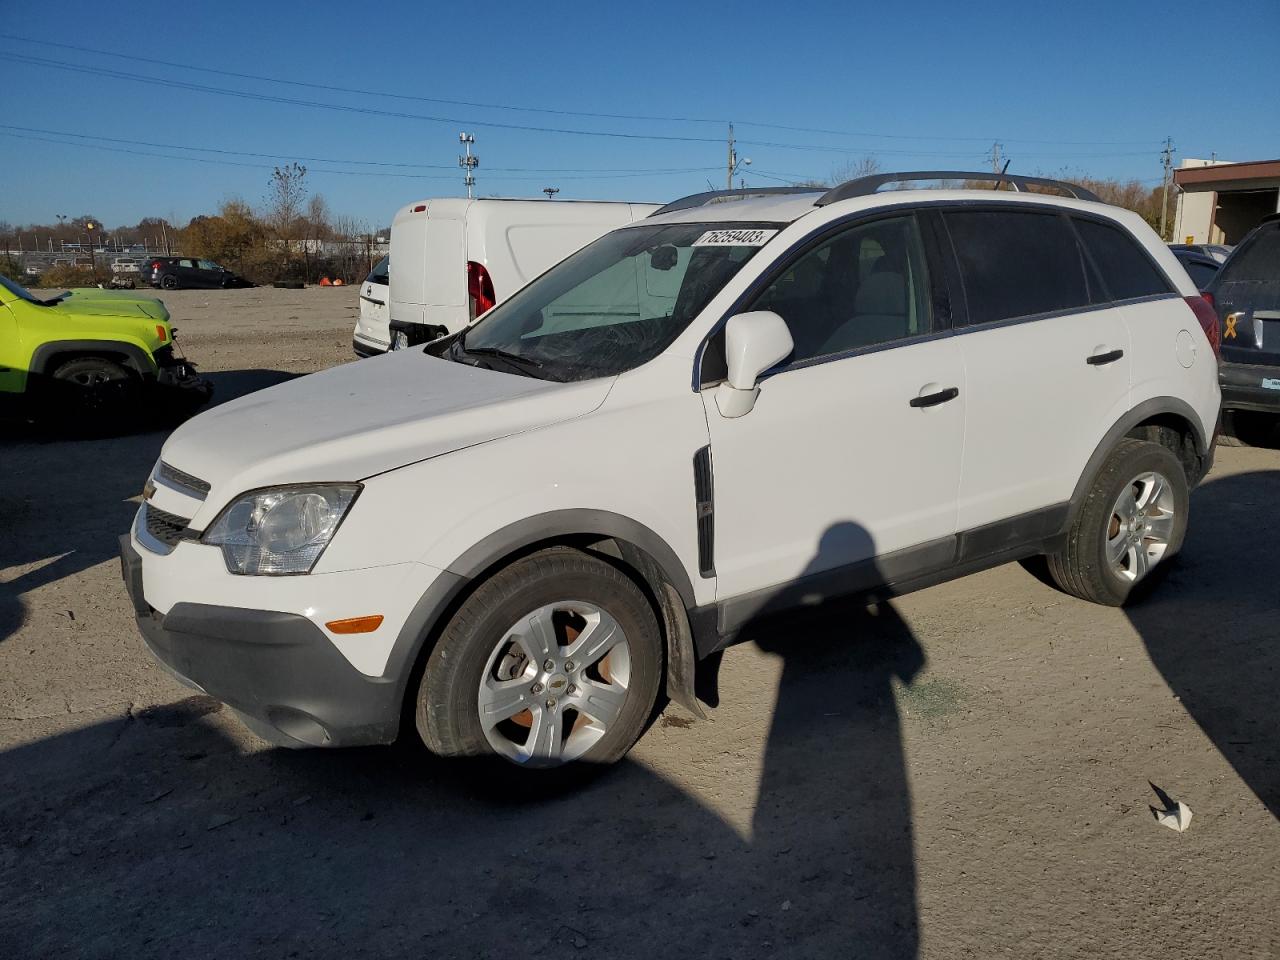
[703, 521, 925, 957]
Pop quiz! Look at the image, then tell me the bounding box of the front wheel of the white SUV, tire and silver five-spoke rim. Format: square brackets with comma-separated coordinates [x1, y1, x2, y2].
[416, 547, 663, 768]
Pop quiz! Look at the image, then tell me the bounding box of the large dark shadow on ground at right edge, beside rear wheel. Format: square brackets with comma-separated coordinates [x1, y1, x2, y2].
[1125, 470, 1280, 818]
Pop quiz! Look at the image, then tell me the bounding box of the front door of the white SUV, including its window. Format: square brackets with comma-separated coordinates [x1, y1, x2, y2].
[703, 212, 965, 619]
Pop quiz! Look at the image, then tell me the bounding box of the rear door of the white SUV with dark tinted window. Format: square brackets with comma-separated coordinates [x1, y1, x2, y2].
[941, 204, 1130, 539]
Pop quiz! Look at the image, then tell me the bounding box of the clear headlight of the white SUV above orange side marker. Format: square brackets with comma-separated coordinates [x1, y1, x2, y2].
[200, 484, 360, 576]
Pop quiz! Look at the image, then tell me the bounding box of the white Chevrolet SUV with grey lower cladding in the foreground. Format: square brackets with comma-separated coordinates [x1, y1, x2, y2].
[122, 173, 1219, 765]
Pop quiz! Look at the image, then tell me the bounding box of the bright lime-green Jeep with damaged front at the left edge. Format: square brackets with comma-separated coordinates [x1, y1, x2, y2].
[0, 276, 212, 425]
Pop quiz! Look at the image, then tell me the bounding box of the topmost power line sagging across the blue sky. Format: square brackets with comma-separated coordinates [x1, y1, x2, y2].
[0, 33, 1172, 146]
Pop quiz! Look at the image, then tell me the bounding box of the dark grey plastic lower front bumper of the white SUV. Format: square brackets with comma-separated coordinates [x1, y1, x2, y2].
[120, 535, 403, 746]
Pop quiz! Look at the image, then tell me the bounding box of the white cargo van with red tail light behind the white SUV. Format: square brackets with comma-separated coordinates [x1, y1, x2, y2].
[381, 198, 658, 352]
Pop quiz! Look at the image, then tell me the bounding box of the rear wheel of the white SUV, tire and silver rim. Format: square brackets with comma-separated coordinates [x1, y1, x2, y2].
[1047, 439, 1189, 607]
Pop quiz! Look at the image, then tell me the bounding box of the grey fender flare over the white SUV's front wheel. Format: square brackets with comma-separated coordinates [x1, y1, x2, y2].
[383, 509, 705, 718]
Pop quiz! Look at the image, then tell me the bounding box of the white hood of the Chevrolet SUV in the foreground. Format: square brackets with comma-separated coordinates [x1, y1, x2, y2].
[160, 349, 613, 525]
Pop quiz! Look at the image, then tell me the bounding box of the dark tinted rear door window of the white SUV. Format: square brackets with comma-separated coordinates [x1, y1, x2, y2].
[942, 210, 1091, 325]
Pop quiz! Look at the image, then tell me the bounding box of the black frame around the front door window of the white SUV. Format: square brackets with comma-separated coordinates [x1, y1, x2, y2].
[692, 204, 952, 393]
